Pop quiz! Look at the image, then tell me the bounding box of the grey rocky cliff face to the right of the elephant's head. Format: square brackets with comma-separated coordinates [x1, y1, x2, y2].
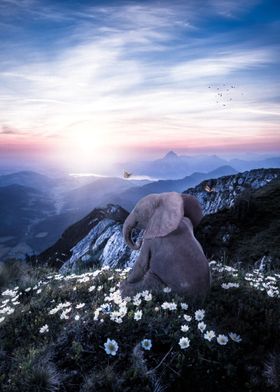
[183, 169, 280, 215]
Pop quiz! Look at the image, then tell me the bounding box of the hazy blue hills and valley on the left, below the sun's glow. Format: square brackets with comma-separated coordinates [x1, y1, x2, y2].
[0, 171, 152, 259]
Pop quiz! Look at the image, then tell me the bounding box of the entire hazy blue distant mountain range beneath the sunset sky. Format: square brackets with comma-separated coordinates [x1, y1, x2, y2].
[0, 151, 279, 258]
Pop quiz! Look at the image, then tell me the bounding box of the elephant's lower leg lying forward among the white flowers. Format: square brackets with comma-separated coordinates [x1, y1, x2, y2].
[120, 271, 166, 298]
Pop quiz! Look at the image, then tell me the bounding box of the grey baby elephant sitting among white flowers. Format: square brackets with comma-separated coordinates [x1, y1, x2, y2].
[120, 192, 210, 298]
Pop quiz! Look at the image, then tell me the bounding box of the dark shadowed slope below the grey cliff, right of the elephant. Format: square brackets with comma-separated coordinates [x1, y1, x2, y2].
[195, 179, 280, 268]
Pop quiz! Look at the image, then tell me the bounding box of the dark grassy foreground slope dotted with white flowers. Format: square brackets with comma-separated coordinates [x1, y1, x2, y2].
[0, 261, 280, 392]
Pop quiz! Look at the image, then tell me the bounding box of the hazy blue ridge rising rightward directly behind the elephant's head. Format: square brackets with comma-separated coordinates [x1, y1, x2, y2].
[107, 166, 236, 211]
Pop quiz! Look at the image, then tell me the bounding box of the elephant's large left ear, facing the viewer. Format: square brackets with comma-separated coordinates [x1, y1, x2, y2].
[144, 192, 184, 239]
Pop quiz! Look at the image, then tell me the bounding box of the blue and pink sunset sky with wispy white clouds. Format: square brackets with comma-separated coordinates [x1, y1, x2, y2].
[0, 0, 280, 170]
